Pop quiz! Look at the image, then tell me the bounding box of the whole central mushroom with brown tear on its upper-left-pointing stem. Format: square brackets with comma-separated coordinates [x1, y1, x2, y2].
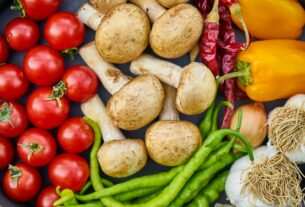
[79, 43, 164, 130]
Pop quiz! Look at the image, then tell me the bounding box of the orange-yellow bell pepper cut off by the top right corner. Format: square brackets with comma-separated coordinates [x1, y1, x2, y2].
[231, 0, 305, 39]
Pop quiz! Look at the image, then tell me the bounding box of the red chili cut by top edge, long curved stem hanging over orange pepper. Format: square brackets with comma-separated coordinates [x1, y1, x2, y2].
[221, 0, 250, 50]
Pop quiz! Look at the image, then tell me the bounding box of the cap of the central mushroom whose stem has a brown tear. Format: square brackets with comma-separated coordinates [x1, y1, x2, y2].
[106, 74, 164, 130]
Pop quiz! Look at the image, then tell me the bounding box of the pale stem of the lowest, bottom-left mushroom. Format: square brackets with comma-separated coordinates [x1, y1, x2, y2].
[81, 95, 125, 142]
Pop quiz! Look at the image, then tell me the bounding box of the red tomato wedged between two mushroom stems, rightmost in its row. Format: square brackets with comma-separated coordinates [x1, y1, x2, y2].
[63, 65, 98, 102]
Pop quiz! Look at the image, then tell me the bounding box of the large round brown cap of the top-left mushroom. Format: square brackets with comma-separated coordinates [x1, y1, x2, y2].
[95, 4, 150, 63]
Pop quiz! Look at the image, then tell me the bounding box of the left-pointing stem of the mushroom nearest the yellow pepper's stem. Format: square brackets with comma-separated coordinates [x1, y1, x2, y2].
[130, 54, 182, 88]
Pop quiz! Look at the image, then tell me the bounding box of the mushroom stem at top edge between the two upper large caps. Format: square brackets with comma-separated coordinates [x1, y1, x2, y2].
[129, 0, 166, 23]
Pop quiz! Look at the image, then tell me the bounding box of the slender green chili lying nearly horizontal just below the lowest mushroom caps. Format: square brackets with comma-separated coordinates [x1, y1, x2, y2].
[76, 165, 184, 201]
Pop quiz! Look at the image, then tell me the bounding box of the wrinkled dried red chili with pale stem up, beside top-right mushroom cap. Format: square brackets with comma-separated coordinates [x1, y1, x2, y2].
[200, 0, 219, 76]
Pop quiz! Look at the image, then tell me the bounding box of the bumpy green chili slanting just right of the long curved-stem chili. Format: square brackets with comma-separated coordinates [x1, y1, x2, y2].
[169, 154, 240, 207]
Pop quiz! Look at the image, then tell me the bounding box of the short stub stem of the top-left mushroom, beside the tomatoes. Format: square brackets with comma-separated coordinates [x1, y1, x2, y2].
[76, 3, 105, 31]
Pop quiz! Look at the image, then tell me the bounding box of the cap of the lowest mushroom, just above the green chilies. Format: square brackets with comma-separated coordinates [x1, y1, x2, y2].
[97, 139, 147, 178]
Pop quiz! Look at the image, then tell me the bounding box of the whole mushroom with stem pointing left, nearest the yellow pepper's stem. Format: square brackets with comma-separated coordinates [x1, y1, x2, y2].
[130, 54, 217, 115]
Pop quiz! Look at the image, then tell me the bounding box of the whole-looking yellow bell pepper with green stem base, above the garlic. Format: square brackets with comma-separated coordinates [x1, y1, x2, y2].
[236, 40, 305, 102]
